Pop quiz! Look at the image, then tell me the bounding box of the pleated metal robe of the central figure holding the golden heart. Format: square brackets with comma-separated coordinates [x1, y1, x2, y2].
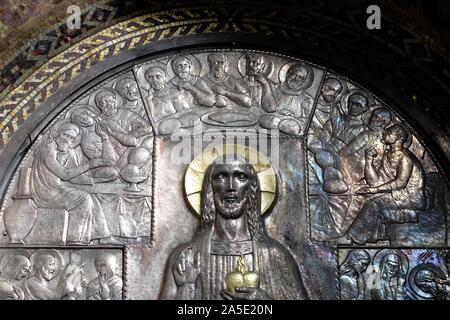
[170, 227, 308, 300]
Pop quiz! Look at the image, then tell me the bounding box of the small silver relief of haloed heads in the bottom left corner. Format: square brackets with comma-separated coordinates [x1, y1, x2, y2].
[0, 249, 123, 300]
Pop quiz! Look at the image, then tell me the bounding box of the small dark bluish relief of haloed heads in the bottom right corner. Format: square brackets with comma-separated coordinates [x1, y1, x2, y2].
[339, 249, 450, 300]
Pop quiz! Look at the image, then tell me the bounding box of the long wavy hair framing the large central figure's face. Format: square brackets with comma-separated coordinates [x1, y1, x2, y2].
[200, 157, 266, 242]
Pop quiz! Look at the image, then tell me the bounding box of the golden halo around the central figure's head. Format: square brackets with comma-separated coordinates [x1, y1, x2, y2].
[184, 144, 277, 216]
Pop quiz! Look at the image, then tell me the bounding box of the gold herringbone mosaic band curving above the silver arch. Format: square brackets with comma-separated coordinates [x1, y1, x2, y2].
[0, 3, 450, 150]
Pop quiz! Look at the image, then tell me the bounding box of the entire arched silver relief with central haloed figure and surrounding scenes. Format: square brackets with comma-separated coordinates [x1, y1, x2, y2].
[0, 50, 450, 300]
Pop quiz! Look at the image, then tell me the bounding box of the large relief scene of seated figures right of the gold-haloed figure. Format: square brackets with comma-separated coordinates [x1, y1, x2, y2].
[308, 76, 445, 245]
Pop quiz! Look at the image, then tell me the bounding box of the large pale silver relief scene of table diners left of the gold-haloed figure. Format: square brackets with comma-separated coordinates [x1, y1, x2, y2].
[1, 76, 153, 244]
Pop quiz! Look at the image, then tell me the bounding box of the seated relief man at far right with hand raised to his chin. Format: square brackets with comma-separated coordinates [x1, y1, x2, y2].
[347, 123, 426, 244]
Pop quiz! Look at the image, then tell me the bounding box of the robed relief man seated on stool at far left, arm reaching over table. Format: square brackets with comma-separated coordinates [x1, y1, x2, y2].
[31, 123, 112, 244]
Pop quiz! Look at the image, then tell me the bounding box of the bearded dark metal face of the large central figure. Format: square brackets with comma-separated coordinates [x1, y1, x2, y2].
[212, 162, 252, 219]
